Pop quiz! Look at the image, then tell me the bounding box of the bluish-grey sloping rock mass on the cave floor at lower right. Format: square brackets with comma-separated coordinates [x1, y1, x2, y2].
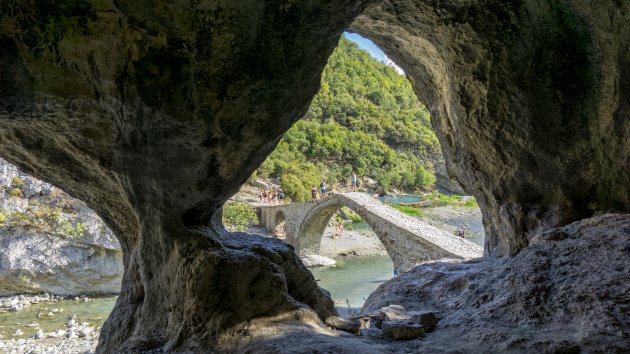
[363, 214, 630, 352]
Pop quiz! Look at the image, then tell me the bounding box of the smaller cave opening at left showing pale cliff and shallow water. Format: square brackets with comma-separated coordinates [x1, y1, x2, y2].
[0, 159, 118, 346]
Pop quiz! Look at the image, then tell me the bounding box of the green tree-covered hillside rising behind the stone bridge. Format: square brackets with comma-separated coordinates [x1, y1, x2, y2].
[256, 38, 442, 201]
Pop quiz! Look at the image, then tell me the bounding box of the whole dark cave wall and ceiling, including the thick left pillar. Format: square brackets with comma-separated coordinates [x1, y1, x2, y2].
[0, 0, 630, 352]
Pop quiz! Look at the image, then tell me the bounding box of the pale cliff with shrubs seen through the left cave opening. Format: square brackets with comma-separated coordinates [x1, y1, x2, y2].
[0, 159, 123, 296]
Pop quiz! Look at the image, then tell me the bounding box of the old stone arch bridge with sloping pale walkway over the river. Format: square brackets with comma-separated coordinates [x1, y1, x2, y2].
[258, 192, 483, 271]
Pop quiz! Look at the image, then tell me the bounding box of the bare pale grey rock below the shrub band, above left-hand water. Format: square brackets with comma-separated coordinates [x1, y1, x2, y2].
[0, 231, 123, 296]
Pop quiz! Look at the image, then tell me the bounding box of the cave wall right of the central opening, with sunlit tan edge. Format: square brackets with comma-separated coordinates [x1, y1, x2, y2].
[351, 0, 630, 256]
